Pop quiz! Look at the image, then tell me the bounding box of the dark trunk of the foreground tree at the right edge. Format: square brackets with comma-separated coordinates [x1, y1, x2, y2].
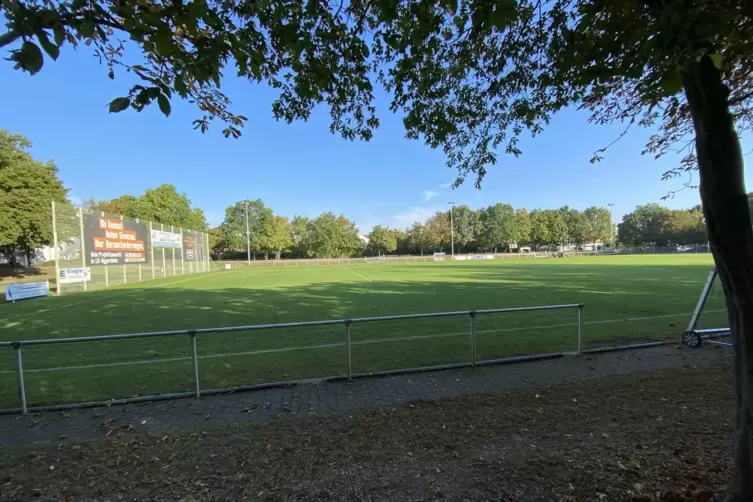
[683, 56, 753, 502]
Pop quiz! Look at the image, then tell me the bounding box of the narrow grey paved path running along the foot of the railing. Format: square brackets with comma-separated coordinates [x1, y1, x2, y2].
[0, 345, 731, 445]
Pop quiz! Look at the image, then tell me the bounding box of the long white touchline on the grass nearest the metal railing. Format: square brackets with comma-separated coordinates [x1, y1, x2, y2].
[0, 310, 723, 374]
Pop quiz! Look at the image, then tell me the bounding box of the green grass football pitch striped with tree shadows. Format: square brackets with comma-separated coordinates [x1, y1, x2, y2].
[0, 255, 725, 408]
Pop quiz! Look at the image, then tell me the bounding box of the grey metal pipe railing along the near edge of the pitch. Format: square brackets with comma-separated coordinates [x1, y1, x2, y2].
[0, 303, 584, 414]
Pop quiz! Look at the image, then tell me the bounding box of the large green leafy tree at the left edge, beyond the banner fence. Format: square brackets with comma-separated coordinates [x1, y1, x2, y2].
[0, 129, 68, 266]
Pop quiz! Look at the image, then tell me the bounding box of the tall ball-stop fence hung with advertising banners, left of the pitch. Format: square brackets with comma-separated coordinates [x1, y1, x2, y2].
[49, 202, 211, 295]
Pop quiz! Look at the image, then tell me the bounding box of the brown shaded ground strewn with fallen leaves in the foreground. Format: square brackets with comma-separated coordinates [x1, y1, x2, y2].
[0, 348, 734, 501]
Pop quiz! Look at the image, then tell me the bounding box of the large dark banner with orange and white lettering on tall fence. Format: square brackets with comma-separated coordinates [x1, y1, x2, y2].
[84, 214, 147, 265]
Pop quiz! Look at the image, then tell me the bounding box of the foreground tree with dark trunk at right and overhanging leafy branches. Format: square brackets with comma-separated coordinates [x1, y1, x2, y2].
[7, 0, 753, 494]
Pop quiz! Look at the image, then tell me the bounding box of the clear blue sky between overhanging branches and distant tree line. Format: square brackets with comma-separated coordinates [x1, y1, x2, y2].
[0, 43, 751, 232]
